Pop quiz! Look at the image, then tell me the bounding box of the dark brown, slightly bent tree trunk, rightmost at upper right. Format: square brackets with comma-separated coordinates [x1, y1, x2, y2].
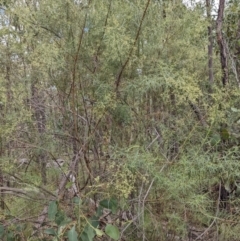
[217, 0, 228, 86]
